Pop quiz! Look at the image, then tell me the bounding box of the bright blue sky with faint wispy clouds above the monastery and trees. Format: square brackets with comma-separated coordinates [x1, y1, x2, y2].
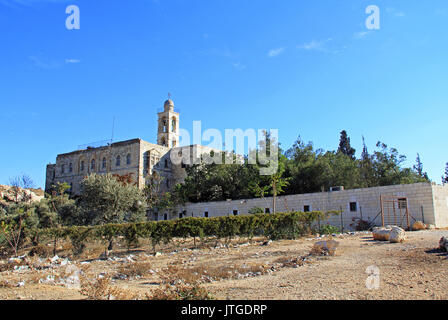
[0, 0, 448, 187]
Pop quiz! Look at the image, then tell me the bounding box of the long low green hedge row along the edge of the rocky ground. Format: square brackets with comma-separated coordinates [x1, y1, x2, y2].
[1, 211, 327, 254]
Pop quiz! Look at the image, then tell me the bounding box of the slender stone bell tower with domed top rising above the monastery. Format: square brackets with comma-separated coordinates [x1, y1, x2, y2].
[157, 95, 179, 148]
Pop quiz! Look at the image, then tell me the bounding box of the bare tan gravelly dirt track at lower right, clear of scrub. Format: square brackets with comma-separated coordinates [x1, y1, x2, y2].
[207, 231, 448, 300]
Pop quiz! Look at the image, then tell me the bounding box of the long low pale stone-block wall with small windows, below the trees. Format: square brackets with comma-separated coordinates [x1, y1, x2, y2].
[159, 183, 448, 230]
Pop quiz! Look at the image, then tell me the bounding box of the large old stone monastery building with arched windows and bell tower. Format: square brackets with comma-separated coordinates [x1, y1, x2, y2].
[45, 100, 218, 195]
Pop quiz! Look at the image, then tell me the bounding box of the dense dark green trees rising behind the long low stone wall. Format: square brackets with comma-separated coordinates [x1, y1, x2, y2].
[177, 131, 428, 202]
